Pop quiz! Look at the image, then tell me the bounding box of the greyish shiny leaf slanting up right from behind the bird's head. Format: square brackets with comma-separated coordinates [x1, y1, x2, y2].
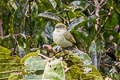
[68, 17, 85, 31]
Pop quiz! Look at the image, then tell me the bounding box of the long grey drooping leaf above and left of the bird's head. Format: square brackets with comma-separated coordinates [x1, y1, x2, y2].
[38, 12, 62, 21]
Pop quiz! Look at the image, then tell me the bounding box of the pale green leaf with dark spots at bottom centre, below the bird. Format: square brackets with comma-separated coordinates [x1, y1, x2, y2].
[42, 58, 65, 80]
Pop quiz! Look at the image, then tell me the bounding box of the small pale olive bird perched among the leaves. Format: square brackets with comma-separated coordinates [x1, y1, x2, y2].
[53, 23, 76, 48]
